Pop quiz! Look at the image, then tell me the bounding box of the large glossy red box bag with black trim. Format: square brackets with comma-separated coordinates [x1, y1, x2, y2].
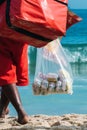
[0, 0, 68, 47]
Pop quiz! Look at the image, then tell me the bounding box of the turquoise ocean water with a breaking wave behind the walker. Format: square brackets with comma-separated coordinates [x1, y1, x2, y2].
[9, 10, 87, 116]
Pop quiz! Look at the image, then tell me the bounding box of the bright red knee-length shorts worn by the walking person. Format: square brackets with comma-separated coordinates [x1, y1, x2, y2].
[0, 38, 29, 86]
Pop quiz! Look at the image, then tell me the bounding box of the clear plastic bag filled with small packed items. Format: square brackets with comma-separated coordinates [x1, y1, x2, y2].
[32, 39, 73, 95]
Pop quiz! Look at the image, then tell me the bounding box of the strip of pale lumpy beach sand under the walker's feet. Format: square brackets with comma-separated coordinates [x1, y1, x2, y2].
[0, 114, 87, 130]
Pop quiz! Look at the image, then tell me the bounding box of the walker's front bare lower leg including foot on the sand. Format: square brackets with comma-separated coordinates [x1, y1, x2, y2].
[3, 84, 29, 124]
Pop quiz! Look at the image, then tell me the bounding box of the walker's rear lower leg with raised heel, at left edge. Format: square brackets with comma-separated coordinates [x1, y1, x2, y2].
[0, 87, 9, 118]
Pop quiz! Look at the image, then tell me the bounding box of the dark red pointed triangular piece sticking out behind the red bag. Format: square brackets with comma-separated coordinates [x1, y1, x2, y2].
[66, 10, 82, 29]
